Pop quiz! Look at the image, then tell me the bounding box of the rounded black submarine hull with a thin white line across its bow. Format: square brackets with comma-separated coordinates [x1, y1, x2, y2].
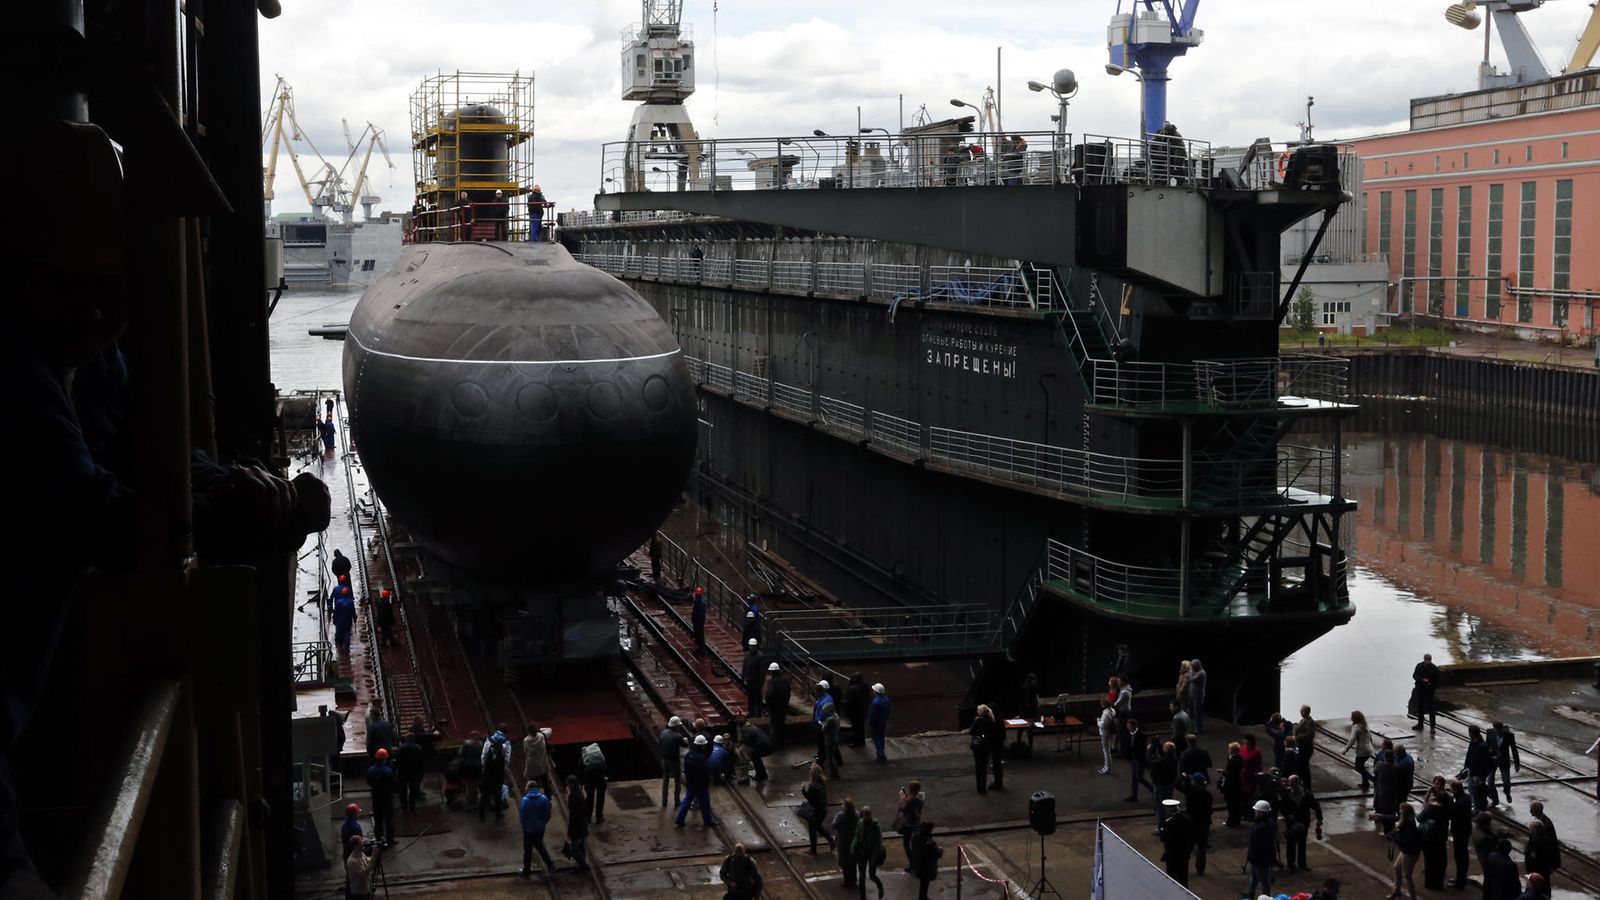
[344, 243, 694, 580]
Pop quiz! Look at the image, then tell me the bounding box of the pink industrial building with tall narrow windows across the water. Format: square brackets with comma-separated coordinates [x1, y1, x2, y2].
[1352, 69, 1600, 335]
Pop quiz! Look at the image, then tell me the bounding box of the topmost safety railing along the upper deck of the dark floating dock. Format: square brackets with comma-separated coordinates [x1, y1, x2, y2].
[600, 130, 1214, 194]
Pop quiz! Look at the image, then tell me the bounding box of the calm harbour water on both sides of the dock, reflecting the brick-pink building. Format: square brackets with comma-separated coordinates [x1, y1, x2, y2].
[270, 299, 1600, 717]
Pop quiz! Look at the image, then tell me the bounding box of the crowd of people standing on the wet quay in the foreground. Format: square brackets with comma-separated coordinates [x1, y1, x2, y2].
[331, 614, 1593, 900]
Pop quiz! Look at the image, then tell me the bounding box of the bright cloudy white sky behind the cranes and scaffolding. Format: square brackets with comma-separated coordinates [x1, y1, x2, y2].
[261, 0, 1589, 211]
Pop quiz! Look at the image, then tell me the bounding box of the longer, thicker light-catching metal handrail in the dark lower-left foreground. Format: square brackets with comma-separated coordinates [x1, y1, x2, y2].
[66, 679, 186, 900]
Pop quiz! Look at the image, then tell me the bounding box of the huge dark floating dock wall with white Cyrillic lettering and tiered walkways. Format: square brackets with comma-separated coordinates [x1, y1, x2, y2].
[562, 135, 1355, 714]
